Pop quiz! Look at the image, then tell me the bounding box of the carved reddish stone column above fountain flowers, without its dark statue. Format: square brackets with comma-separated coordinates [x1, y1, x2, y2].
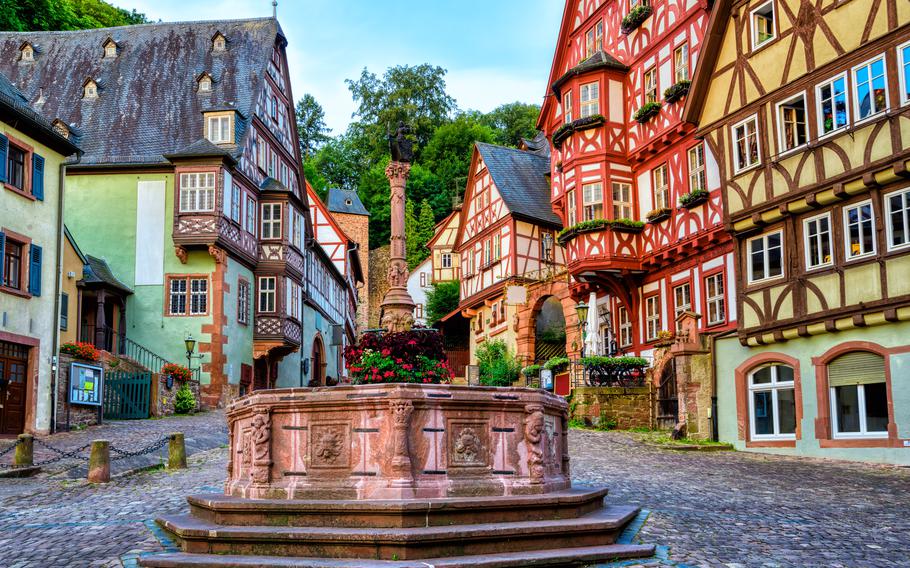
[380, 162, 414, 332]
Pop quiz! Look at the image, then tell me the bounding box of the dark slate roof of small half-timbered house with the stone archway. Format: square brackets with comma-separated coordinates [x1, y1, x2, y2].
[477, 142, 562, 227]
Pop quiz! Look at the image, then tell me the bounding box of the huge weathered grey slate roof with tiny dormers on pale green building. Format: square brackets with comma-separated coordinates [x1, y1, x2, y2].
[0, 18, 284, 165]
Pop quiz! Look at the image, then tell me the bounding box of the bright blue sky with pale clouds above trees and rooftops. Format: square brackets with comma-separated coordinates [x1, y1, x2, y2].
[113, 0, 563, 133]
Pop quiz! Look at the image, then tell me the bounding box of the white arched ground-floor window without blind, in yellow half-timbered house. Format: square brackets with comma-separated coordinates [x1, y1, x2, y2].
[749, 363, 796, 440]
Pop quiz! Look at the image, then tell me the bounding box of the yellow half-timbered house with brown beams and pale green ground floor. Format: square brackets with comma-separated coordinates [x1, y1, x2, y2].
[686, 0, 910, 464]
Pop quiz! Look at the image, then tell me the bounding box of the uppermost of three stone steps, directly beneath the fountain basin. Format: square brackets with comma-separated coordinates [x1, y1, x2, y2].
[187, 487, 607, 528]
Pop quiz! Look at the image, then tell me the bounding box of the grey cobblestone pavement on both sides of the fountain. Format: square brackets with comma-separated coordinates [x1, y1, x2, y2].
[0, 426, 910, 568]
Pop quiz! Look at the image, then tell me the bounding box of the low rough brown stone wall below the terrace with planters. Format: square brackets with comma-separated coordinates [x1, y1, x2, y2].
[569, 385, 654, 430]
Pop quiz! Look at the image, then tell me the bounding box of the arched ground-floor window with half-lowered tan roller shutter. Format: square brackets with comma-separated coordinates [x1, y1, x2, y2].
[828, 351, 888, 438]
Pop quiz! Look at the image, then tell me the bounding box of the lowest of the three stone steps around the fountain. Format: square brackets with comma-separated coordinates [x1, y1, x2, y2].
[139, 544, 654, 568]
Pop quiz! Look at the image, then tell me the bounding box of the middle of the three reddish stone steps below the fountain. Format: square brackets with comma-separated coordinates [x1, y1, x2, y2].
[158, 506, 638, 560]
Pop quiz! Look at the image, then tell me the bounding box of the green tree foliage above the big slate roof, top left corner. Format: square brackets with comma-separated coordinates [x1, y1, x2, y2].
[0, 0, 148, 32]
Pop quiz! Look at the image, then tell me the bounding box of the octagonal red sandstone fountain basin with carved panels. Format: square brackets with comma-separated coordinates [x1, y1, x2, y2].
[225, 384, 570, 499]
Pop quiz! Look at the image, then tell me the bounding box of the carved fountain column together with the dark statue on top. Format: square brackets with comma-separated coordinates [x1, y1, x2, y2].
[380, 122, 414, 332]
